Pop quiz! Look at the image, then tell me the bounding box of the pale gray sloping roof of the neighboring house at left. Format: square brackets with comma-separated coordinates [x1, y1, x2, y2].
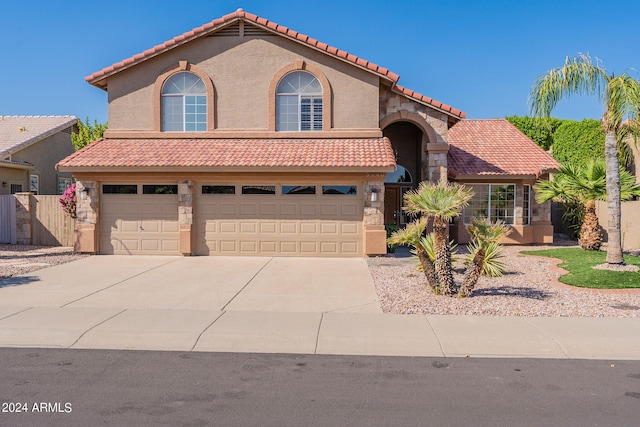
[0, 116, 78, 159]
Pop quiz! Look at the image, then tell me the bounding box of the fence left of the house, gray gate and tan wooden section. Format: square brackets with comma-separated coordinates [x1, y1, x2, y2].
[0, 194, 76, 246]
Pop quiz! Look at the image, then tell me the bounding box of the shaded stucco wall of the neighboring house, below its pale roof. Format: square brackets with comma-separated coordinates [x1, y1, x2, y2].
[0, 132, 75, 194]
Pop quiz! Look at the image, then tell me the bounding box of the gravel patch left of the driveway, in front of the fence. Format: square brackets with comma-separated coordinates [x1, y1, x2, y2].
[0, 244, 89, 280]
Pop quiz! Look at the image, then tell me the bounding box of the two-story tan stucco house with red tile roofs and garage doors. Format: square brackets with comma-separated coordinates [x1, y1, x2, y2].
[58, 10, 557, 256]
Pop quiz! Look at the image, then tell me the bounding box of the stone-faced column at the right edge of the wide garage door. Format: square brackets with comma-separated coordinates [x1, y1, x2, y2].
[363, 173, 387, 255]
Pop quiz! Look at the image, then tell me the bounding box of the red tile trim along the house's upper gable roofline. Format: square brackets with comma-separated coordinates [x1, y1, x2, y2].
[85, 9, 466, 118]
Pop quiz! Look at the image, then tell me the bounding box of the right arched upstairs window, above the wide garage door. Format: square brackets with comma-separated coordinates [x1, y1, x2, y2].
[276, 71, 322, 131]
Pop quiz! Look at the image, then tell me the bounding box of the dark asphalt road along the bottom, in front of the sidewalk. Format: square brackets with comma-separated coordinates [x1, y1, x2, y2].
[0, 348, 640, 427]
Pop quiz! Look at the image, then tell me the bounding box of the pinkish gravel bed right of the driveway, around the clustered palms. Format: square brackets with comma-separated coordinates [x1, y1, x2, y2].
[368, 241, 640, 317]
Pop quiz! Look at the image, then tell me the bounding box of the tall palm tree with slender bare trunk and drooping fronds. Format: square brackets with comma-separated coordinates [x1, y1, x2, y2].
[529, 54, 640, 264]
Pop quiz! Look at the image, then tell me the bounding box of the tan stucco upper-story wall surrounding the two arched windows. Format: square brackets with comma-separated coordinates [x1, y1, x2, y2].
[108, 36, 379, 130]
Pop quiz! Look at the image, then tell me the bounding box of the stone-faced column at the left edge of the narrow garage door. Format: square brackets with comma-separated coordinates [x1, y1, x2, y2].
[74, 181, 100, 254]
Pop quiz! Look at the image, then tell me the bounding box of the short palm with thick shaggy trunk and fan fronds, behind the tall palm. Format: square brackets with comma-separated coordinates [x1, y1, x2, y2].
[534, 159, 640, 250]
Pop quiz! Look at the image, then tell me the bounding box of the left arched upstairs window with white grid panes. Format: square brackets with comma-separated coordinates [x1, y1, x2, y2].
[162, 72, 207, 132]
